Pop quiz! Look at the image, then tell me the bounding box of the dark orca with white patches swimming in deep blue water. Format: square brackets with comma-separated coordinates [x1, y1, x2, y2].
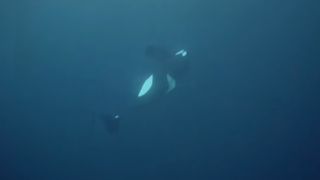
[100, 45, 189, 134]
